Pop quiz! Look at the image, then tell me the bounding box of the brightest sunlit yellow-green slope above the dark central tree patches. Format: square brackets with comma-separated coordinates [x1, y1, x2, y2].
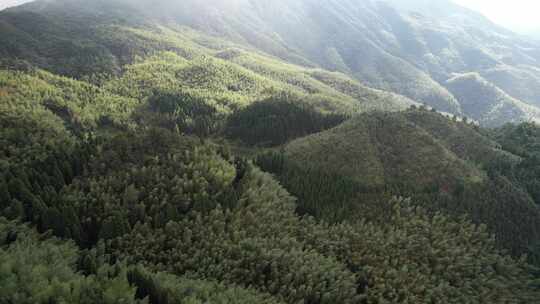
[105, 45, 414, 113]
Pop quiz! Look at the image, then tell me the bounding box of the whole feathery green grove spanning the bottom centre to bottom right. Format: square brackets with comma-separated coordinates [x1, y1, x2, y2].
[109, 167, 537, 303]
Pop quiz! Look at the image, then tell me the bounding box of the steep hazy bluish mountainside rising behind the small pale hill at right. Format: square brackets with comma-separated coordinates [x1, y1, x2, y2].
[86, 0, 540, 124]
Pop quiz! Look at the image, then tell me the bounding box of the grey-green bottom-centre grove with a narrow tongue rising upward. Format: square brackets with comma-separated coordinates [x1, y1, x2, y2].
[112, 169, 364, 303]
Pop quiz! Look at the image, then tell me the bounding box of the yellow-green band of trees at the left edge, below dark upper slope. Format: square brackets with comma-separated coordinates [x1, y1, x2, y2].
[0, 70, 138, 130]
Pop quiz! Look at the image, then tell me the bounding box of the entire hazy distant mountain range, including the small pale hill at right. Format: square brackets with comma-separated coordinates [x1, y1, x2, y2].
[0, 0, 540, 126]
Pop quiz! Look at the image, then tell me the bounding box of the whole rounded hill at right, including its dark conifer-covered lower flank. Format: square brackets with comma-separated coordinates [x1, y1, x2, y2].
[258, 109, 540, 253]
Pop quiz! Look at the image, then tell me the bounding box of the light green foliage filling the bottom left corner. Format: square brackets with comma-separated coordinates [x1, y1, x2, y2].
[0, 217, 280, 304]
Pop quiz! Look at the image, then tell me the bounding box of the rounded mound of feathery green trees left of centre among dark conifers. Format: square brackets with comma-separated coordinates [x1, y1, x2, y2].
[60, 130, 236, 245]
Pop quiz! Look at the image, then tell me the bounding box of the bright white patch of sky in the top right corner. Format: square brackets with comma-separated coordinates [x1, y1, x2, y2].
[454, 0, 540, 33]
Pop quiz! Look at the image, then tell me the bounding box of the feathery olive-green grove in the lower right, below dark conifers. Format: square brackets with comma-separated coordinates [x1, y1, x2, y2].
[301, 199, 537, 303]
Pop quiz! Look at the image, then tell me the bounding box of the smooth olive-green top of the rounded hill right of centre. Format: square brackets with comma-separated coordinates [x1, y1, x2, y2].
[285, 109, 483, 188]
